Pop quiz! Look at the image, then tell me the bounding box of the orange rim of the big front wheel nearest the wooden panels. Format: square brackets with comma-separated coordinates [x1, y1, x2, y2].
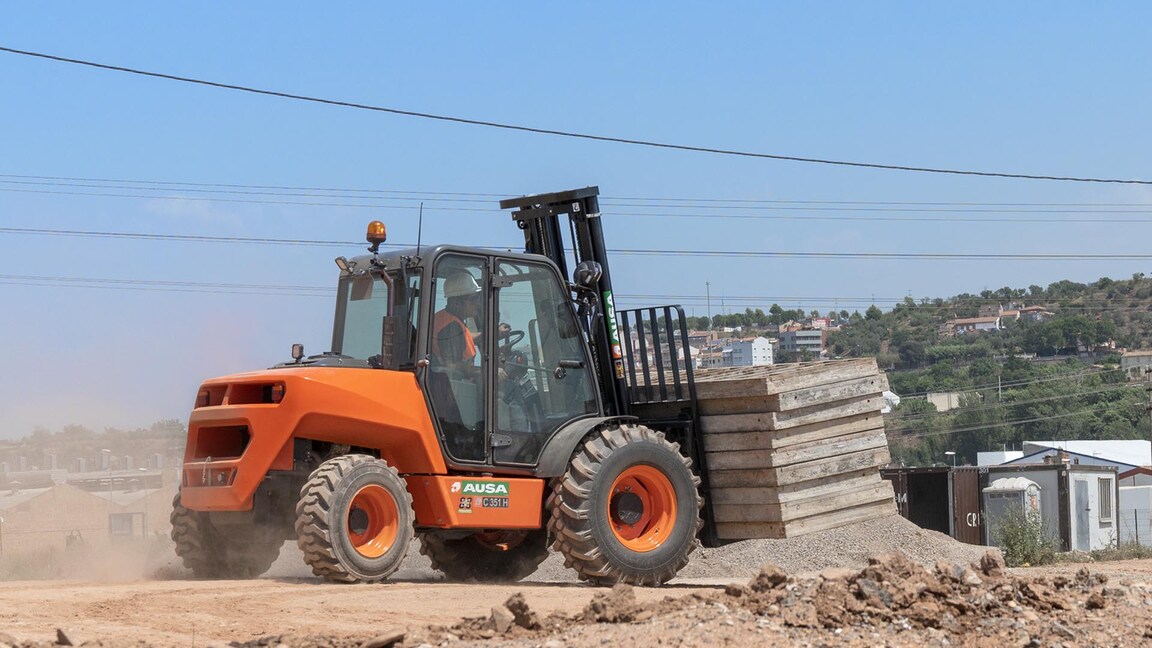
[608, 466, 676, 551]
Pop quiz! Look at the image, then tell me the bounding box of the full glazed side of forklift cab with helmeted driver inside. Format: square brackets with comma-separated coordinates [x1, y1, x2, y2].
[419, 247, 601, 467]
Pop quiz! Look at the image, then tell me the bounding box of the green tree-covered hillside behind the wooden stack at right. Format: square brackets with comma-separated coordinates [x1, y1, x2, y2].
[828, 273, 1152, 466]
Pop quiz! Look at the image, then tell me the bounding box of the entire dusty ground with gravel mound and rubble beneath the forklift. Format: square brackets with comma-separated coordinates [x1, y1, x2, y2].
[0, 519, 1152, 648]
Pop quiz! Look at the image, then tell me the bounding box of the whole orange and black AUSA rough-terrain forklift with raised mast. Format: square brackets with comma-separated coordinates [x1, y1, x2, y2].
[172, 187, 714, 586]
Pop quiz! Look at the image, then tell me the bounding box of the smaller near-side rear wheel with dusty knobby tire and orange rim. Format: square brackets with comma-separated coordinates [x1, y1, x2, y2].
[296, 454, 416, 582]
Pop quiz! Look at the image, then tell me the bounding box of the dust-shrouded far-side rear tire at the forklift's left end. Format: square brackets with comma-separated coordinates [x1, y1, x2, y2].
[169, 492, 285, 579]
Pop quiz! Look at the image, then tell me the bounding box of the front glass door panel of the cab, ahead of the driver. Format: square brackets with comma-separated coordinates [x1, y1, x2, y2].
[490, 258, 600, 466]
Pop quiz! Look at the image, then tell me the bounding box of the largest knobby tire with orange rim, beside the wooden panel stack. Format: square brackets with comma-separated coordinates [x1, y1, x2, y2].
[548, 425, 704, 586]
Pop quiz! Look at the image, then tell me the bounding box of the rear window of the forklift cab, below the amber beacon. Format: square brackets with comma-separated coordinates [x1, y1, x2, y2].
[332, 268, 392, 360]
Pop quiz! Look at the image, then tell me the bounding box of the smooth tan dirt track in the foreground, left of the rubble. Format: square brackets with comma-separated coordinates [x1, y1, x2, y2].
[0, 571, 717, 646]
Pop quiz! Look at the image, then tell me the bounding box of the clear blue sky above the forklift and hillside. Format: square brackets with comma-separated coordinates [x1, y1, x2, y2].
[0, 2, 1152, 438]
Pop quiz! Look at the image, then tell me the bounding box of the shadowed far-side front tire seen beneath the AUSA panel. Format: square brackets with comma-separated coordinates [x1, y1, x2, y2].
[418, 529, 548, 582]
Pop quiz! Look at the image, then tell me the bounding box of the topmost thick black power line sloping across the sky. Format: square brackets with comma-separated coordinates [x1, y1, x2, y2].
[0, 46, 1152, 184]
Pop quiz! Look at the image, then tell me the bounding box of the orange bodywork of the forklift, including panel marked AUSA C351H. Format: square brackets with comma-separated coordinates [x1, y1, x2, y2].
[180, 367, 544, 528]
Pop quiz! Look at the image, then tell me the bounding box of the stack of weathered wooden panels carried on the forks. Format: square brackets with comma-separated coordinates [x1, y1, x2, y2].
[696, 359, 896, 540]
